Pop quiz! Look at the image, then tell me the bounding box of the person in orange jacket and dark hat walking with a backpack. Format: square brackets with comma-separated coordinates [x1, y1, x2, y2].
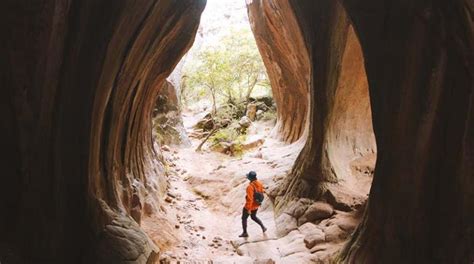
[239, 171, 267, 237]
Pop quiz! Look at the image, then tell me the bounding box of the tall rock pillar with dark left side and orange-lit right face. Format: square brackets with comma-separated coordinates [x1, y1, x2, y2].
[264, 1, 376, 210]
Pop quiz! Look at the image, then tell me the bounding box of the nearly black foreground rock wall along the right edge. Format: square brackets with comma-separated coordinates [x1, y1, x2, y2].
[343, 0, 474, 263]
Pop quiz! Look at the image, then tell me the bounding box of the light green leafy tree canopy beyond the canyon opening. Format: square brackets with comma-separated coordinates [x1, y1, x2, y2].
[182, 29, 271, 112]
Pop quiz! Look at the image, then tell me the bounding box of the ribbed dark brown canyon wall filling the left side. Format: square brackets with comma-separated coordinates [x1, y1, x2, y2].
[0, 0, 205, 263]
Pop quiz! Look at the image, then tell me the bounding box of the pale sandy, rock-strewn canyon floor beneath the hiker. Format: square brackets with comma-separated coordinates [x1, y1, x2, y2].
[142, 112, 365, 263]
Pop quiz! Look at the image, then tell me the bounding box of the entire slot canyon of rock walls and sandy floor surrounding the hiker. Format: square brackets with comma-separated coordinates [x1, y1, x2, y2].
[0, 0, 474, 264]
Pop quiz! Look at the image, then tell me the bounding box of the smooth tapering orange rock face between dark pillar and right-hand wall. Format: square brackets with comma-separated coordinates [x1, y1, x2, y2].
[324, 27, 376, 184]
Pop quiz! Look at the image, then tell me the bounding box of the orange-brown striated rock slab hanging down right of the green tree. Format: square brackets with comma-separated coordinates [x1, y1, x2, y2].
[247, 0, 310, 143]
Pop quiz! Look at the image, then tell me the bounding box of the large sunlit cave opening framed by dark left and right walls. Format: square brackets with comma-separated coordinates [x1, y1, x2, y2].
[142, 0, 376, 261]
